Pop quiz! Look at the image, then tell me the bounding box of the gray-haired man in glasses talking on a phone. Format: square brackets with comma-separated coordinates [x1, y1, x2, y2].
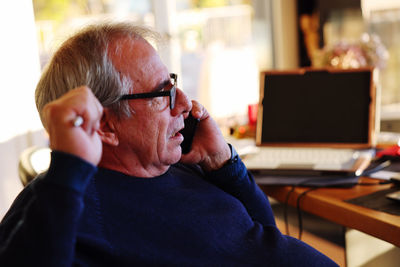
[0, 24, 336, 266]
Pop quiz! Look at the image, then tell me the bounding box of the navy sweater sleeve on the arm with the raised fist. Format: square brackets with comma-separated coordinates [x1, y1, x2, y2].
[0, 151, 97, 266]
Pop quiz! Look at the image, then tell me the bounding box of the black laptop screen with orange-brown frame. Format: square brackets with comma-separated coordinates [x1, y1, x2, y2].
[257, 69, 374, 144]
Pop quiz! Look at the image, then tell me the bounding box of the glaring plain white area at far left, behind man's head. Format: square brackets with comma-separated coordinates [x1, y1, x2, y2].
[0, 0, 41, 142]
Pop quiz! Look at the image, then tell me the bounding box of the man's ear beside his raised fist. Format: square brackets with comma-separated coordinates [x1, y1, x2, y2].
[97, 108, 119, 146]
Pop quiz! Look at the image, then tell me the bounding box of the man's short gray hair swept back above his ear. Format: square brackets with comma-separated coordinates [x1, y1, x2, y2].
[35, 23, 161, 122]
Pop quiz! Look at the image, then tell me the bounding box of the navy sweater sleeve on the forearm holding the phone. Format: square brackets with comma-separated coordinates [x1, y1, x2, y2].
[205, 158, 275, 226]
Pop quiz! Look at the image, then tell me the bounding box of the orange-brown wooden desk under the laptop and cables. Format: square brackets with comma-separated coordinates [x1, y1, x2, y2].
[260, 177, 400, 247]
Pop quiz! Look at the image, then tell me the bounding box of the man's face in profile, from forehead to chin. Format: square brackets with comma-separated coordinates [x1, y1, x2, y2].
[108, 37, 191, 172]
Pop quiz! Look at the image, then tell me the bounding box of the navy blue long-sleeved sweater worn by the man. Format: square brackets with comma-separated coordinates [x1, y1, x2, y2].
[0, 152, 336, 266]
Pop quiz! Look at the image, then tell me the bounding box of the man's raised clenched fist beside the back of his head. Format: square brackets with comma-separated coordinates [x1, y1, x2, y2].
[42, 86, 103, 165]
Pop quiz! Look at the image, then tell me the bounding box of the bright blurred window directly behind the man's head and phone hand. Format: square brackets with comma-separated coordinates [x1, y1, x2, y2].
[33, 0, 273, 124]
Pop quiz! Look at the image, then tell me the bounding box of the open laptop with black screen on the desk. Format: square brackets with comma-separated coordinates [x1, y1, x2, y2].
[239, 68, 376, 176]
